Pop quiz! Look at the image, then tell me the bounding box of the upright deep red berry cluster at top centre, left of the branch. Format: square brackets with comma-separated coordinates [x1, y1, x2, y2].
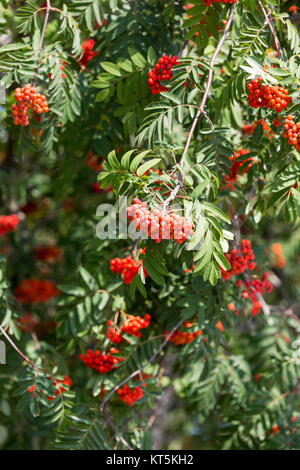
[148, 54, 178, 95]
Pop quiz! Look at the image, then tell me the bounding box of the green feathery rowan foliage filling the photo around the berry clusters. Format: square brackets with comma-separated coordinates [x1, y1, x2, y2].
[0, 0, 300, 450]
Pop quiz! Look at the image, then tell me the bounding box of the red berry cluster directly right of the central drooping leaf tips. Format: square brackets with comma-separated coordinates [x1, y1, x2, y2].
[221, 238, 255, 280]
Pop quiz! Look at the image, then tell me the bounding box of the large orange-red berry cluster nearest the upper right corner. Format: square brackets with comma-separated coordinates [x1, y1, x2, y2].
[247, 77, 292, 113]
